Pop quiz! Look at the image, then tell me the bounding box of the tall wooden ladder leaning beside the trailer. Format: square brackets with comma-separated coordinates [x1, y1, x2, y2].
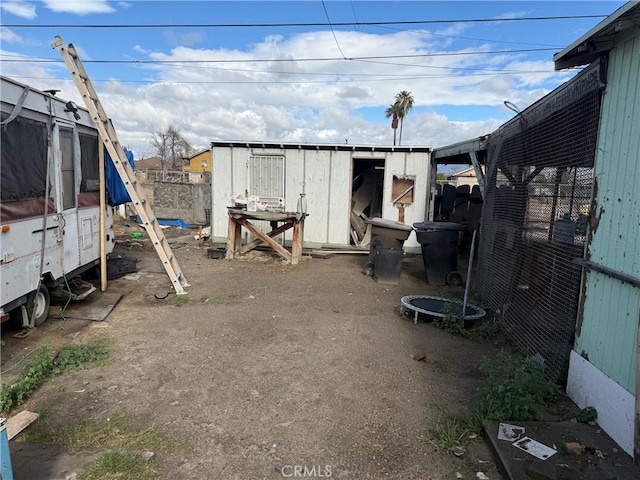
[51, 36, 190, 295]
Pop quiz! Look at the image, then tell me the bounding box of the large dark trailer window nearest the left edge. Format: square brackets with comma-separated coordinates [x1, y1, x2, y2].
[0, 112, 47, 202]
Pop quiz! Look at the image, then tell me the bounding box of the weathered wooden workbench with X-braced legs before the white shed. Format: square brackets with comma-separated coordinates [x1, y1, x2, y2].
[226, 208, 306, 265]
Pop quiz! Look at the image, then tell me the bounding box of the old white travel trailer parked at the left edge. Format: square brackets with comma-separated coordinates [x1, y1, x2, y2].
[0, 77, 114, 326]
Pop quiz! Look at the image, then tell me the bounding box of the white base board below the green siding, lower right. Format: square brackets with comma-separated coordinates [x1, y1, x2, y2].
[567, 350, 635, 456]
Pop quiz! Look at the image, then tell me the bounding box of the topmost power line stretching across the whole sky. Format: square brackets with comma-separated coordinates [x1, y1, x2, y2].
[0, 15, 608, 28]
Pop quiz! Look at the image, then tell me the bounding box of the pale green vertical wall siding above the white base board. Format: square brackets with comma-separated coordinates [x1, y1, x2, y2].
[575, 31, 640, 393]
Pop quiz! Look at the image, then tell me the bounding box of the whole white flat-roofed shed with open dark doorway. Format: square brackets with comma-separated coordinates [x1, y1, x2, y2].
[211, 142, 432, 252]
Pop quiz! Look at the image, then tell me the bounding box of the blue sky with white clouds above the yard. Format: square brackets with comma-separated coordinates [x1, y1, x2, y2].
[0, 0, 624, 158]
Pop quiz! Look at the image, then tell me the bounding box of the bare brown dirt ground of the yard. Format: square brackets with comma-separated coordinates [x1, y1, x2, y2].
[2, 231, 510, 480]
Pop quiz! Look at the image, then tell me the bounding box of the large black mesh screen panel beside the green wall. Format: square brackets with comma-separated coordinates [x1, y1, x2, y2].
[478, 64, 602, 380]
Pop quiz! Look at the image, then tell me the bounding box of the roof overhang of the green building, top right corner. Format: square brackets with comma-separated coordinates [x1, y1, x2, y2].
[553, 1, 640, 70]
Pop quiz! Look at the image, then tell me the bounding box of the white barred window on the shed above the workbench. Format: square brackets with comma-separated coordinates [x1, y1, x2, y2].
[248, 155, 285, 207]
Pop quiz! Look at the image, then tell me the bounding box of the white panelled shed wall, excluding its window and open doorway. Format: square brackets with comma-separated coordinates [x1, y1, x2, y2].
[211, 145, 430, 250]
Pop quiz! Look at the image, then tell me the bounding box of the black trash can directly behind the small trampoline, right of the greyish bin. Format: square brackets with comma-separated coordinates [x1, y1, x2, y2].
[413, 222, 465, 285]
